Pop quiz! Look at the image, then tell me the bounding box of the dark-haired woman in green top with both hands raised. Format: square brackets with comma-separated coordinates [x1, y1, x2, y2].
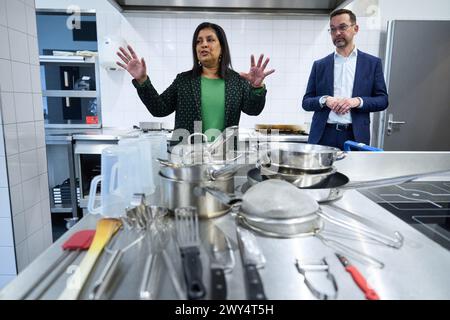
[117, 22, 275, 139]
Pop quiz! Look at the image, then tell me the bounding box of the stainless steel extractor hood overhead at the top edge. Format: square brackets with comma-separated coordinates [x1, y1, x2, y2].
[108, 0, 352, 14]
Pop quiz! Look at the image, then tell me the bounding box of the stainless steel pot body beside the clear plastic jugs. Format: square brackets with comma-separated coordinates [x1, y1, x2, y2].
[159, 172, 234, 218]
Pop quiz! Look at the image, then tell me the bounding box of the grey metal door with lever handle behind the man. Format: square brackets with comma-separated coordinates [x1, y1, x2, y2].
[378, 20, 450, 151]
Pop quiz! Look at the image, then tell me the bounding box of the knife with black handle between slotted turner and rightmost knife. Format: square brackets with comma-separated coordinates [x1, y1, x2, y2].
[209, 226, 235, 300]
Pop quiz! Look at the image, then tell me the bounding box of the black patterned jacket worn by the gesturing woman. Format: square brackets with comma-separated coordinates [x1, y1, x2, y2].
[133, 70, 267, 133]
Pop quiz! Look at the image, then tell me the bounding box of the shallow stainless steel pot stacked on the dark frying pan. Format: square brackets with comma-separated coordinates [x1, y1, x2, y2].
[260, 142, 345, 172]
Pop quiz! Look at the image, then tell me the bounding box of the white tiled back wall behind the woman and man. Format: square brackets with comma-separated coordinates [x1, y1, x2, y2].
[97, 11, 379, 127]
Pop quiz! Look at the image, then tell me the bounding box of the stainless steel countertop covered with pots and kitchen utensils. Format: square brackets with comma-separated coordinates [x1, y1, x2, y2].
[0, 152, 450, 300]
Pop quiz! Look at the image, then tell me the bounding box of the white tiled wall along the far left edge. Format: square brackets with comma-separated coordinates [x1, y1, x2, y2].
[0, 0, 52, 288]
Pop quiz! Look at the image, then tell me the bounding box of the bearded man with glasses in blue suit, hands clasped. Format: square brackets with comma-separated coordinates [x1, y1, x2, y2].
[302, 9, 388, 149]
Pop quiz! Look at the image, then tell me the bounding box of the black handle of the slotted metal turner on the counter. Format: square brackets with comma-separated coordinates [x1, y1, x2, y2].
[180, 247, 206, 300]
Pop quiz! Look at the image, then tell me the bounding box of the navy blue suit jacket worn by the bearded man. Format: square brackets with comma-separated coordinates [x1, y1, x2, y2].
[302, 50, 388, 145]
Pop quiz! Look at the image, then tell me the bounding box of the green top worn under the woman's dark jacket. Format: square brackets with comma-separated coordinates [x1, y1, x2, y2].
[200, 77, 225, 141]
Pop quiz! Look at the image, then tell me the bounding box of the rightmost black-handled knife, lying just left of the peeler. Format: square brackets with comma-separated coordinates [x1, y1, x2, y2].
[236, 226, 267, 300]
